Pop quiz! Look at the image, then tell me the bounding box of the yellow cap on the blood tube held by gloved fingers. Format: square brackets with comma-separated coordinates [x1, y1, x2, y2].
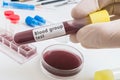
[89, 10, 110, 23]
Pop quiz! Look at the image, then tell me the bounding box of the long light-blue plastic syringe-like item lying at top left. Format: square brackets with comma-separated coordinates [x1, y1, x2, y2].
[3, 1, 35, 10]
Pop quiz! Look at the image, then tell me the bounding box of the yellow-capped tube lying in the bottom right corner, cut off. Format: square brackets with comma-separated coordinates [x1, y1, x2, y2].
[94, 68, 120, 80]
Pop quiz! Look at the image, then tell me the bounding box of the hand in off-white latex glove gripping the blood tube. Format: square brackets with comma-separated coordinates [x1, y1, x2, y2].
[70, 0, 120, 48]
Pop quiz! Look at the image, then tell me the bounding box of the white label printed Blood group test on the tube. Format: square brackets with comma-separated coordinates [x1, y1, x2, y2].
[33, 23, 66, 41]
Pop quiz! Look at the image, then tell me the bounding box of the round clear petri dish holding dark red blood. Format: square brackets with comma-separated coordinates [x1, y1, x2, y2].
[40, 44, 84, 79]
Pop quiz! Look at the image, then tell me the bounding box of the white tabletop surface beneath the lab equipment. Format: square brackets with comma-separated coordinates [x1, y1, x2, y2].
[0, 0, 120, 80]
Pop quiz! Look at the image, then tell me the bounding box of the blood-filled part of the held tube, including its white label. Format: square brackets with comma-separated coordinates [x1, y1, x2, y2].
[14, 21, 84, 44]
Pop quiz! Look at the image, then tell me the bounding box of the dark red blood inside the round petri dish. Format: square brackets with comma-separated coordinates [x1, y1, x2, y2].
[42, 50, 82, 76]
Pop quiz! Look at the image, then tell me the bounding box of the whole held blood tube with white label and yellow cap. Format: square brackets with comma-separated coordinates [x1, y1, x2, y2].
[14, 10, 110, 44]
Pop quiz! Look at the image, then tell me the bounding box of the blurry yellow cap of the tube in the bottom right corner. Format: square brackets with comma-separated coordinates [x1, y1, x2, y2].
[94, 70, 114, 80]
